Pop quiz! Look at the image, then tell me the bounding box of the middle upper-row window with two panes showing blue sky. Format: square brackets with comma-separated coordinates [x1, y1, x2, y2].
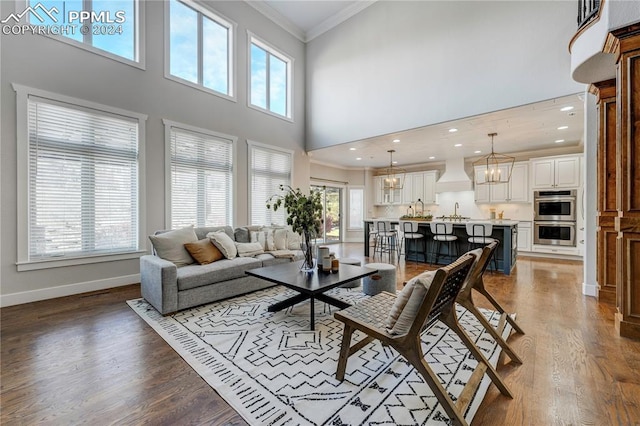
[167, 0, 234, 97]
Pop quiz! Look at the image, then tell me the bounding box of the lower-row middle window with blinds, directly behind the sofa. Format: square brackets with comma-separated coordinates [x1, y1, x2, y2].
[165, 121, 235, 228]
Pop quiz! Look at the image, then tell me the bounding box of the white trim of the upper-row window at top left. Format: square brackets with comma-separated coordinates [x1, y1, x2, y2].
[16, 0, 146, 70]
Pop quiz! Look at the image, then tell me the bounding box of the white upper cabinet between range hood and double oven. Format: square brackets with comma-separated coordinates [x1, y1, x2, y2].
[474, 162, 530, 204]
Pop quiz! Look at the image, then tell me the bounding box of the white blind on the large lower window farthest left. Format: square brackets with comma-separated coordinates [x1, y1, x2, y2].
[28, 95, 139, 260]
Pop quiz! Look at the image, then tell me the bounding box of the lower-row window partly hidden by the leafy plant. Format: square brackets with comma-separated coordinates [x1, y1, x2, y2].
[248, 142, 293, 225]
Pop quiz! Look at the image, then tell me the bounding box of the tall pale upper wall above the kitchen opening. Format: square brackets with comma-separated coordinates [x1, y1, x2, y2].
[307, 1, 584, 150]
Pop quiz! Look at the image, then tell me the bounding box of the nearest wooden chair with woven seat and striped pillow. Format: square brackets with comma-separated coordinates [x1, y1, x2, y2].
[334, 254, 513, 425]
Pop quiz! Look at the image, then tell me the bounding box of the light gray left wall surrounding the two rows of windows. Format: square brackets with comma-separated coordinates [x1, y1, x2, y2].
[0, 1, 309, 305]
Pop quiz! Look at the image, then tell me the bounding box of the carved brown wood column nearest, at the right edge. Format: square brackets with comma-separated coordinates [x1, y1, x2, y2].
[605, 24, 640, 339]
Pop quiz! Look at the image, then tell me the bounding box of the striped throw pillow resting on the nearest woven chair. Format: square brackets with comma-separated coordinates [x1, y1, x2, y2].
[385, 271, 436, 335]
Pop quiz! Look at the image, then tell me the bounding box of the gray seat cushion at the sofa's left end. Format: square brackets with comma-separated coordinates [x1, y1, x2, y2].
[178, 257, 262, 291]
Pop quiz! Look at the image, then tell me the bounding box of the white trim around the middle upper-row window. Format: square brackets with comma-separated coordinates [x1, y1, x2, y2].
[163, 0, 238, 102]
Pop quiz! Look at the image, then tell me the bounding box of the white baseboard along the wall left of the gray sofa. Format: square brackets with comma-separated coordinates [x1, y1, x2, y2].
[0, 274, 140, 308]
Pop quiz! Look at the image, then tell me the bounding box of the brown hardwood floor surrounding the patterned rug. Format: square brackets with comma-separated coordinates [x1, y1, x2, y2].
[0, 244, 640, 425]
